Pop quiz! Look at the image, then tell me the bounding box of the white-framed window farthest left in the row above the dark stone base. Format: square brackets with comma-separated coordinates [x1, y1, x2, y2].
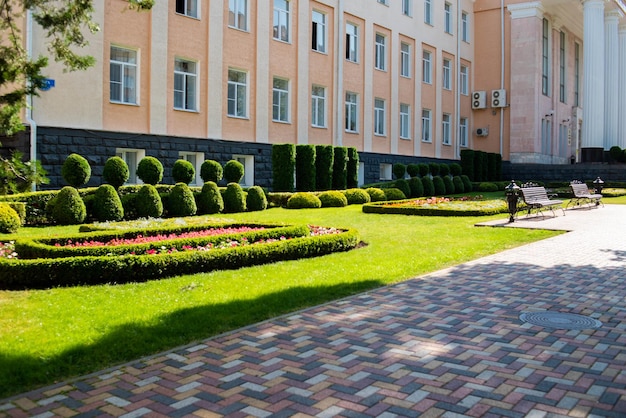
[109, 45, 139, 105]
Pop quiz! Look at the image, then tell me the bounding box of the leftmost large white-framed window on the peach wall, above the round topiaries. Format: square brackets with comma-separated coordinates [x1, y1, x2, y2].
[109, 46, 137, 104]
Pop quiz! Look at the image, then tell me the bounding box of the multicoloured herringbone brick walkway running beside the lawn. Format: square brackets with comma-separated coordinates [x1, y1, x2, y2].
[0, 205, 626, 417]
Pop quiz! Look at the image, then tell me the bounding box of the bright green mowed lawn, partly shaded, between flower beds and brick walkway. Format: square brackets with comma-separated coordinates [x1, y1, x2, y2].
[0, 206, 557, 397]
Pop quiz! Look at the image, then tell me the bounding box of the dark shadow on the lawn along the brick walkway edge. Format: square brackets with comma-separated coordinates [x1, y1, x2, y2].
[0, 280, 384, 398]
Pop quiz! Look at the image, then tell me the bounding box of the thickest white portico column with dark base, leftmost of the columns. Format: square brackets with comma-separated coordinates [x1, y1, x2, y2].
[582, 0, 604, 162]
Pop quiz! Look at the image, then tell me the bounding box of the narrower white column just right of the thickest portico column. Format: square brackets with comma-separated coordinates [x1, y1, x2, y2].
[604, 10, 621, 150]
